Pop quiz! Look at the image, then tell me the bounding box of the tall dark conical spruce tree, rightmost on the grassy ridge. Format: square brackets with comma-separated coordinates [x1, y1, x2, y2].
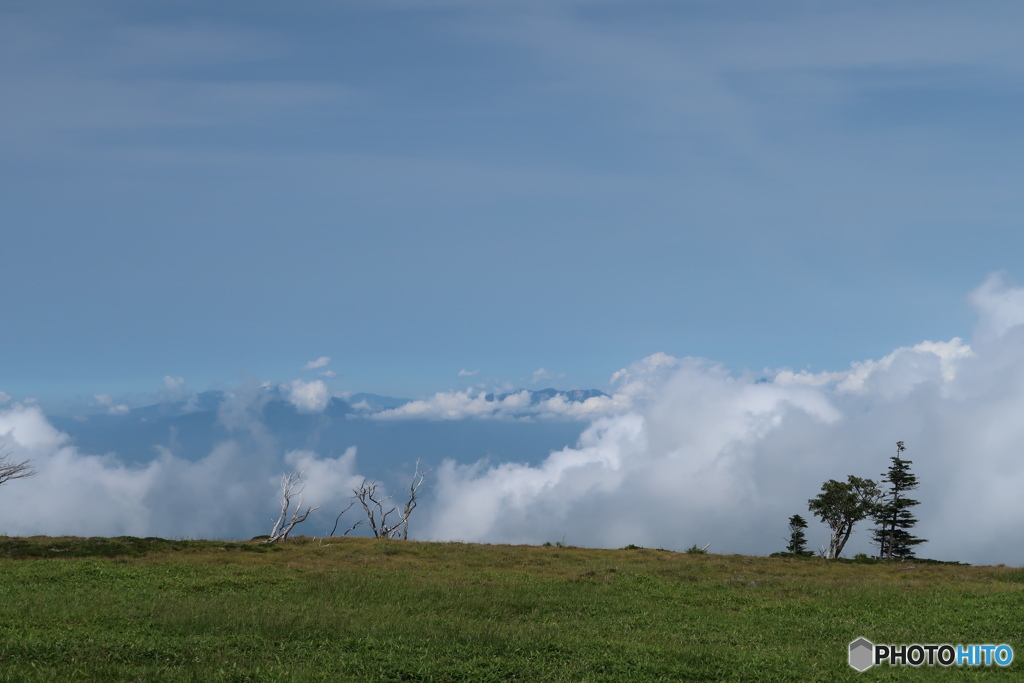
[871, 441, 927, 560]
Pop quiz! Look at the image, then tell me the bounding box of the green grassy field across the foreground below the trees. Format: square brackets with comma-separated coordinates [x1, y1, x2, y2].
[0, 538, 1024, 682]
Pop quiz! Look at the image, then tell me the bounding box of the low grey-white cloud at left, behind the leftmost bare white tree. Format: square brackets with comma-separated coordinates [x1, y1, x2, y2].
[0, 403, 372, 538]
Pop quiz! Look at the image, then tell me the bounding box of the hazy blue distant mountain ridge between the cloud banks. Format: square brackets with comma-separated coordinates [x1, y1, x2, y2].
[49, 386, 607, 470]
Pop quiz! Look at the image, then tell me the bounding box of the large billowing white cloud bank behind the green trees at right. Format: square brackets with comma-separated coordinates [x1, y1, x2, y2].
[417, 281, 1024, 564]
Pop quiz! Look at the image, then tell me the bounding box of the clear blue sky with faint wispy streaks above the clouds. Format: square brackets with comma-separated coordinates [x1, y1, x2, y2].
[0, 0, 1024, 399]
